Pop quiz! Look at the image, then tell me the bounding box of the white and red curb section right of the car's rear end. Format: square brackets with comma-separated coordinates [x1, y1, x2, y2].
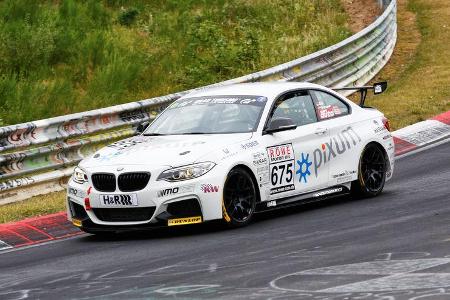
[392, 111, 450, 156]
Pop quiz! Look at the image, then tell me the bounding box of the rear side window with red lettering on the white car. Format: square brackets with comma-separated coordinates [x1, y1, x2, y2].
[311, 91, 348, 120]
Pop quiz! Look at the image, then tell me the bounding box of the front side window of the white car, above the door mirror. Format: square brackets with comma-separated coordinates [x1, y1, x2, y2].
[270, 91, 317, 126]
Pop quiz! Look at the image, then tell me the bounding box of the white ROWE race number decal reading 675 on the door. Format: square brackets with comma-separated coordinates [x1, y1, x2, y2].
[267, 144, 295, 195]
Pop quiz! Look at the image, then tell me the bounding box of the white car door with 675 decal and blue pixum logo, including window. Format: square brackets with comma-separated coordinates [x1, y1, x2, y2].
[262, 90, 329, 200]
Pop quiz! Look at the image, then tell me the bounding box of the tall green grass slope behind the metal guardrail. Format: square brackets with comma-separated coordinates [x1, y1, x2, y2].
[0, 0, 350, 125]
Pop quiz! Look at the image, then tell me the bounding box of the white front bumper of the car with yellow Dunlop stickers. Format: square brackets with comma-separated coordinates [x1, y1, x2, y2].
[67, 166, 224, 232]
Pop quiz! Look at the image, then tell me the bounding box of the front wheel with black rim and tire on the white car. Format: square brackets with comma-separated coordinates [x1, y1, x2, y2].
[223, 168, 258, 227]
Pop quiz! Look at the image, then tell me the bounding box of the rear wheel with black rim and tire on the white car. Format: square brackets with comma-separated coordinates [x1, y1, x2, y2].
[352, 143, 387, 197]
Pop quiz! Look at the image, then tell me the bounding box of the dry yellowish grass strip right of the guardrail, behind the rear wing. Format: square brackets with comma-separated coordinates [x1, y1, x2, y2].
[366, 0, 450, 129]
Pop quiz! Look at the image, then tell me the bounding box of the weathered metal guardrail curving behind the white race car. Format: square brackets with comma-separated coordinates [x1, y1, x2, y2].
[0, 0, 397, 204]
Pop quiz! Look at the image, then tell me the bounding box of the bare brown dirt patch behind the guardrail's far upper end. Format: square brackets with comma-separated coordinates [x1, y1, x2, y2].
[341, 0, 382, 33]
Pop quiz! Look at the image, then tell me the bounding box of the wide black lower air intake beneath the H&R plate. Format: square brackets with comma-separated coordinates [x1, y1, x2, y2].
[92, 206, 156, 222]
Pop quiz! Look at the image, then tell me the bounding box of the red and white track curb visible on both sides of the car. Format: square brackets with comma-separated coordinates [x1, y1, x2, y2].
[0, 111, 450, 251]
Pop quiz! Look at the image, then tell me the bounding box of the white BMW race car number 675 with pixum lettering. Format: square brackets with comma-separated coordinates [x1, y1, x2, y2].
[67, 83, 394, 233]
